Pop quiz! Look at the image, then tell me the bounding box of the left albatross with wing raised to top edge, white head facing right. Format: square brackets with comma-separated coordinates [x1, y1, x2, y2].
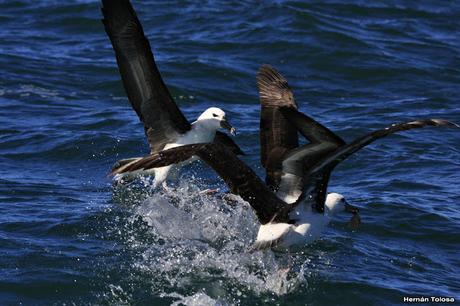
[102, 0, 243, 187]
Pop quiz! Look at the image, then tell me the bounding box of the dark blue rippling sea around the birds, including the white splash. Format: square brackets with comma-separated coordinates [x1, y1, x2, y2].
[0, 0, 460, 305]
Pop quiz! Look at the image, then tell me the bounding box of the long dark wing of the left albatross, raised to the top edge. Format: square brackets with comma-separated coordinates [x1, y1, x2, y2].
[102, 0, 190, 152]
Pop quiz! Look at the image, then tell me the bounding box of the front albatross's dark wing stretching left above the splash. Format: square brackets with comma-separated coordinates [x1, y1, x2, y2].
[114, 143, 292, 224]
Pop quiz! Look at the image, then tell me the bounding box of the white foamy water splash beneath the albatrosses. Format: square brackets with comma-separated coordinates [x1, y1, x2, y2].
[112, 181, 307, 305]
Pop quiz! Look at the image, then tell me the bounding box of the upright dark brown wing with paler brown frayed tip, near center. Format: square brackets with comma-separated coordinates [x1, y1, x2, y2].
[257, 65, 299, 189]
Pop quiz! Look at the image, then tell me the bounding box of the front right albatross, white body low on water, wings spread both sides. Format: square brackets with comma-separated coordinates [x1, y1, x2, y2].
[110, 112, 458, 249]
